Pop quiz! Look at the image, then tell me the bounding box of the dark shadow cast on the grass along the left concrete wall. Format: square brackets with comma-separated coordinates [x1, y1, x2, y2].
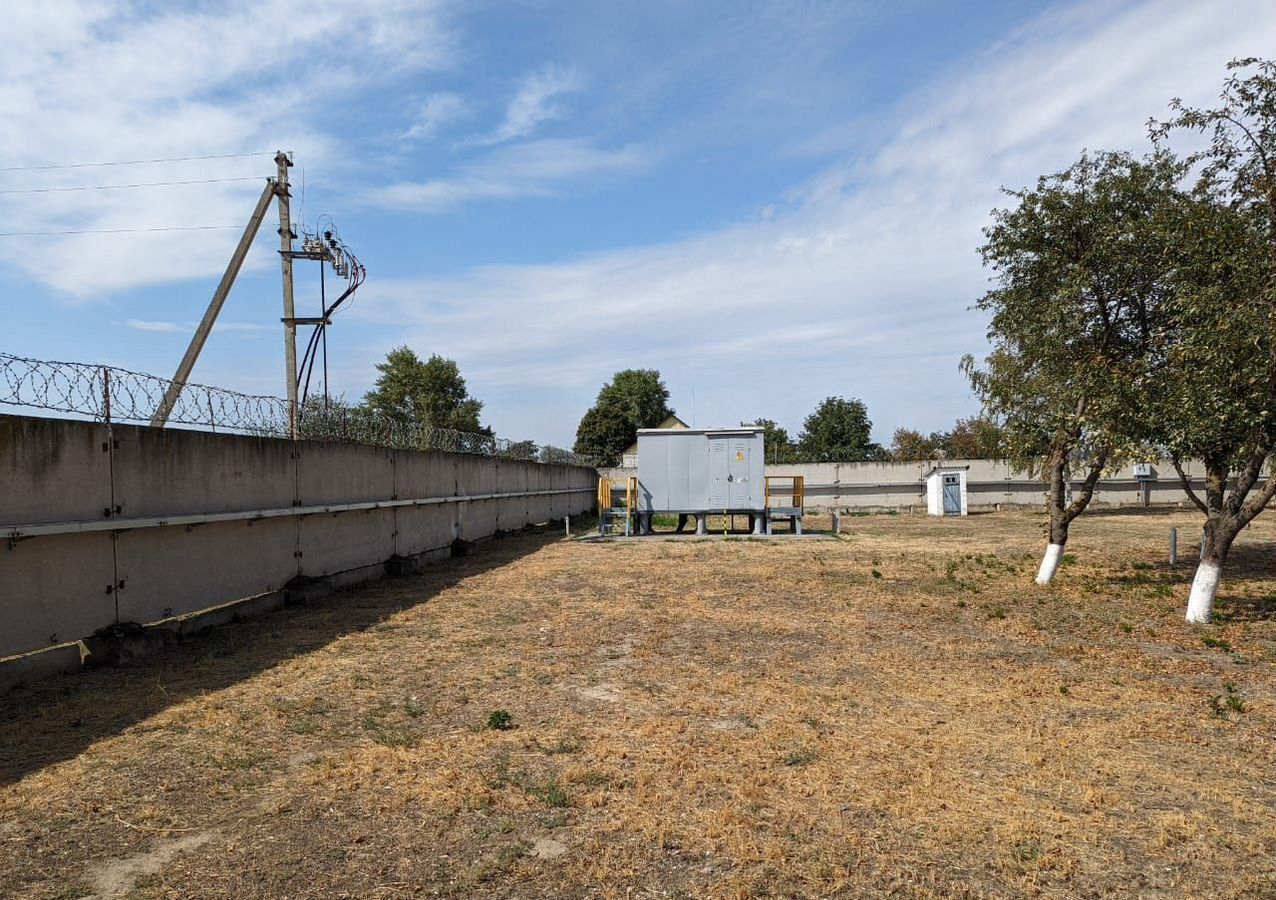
[0, 530, 559, 785]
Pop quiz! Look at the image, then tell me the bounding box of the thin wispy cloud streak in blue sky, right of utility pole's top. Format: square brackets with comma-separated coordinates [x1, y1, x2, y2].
[364, 139, 655, 212]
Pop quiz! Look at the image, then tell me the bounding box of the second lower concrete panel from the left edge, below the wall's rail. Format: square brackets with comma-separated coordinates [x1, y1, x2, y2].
[116, 517, 299, 624]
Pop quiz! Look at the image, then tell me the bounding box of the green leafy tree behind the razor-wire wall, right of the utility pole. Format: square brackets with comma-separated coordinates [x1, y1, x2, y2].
[364, 347, 491, 435]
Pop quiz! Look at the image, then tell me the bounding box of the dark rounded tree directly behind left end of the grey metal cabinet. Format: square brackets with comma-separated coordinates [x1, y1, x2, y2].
[575, 369, 674, 466]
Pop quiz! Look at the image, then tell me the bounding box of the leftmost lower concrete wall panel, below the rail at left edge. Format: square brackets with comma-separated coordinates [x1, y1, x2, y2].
[0, 531, 115, 656]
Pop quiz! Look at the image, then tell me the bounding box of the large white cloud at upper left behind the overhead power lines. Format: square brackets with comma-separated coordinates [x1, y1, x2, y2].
[0, 0, 456, 299]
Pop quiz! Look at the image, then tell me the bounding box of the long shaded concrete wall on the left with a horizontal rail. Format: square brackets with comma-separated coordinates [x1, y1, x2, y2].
[0, 415, 596, 657]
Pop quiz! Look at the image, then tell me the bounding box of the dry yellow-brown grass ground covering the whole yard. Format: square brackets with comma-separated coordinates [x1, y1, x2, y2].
[0, 513, 1276, 899]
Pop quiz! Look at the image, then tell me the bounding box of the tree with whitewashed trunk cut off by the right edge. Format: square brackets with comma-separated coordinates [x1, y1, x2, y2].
[1151, 59, 1276, 623]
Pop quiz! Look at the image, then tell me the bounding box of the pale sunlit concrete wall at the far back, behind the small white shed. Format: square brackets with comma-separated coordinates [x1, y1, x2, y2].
[600, 460, 1205, 512]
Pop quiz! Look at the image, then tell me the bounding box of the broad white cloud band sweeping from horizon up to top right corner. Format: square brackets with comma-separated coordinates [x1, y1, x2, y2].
[344, 0, 1276, 442]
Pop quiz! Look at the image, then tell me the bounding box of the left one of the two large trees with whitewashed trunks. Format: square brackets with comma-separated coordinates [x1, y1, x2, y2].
[962, 153, 1182, 585]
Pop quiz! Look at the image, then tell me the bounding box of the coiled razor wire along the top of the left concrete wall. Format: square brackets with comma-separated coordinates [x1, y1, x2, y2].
[0, 354, 592, 466]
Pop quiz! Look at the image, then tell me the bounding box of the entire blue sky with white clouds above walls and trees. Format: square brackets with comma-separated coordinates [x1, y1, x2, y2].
[0, 0, 1276, 444]
